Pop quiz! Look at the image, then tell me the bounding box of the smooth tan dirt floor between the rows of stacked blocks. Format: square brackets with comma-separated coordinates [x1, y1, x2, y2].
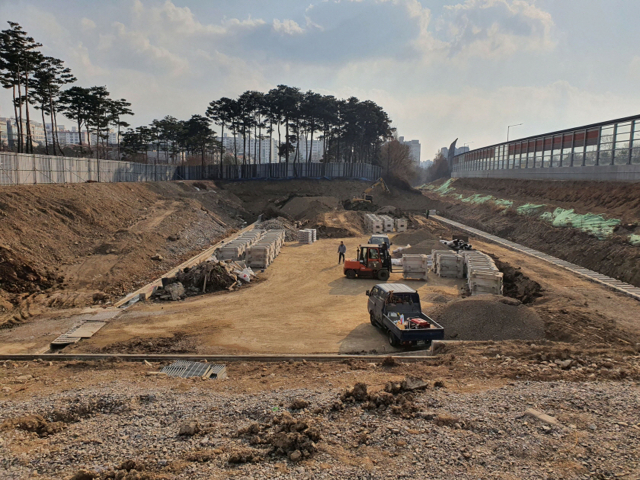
[74, 237, 463, 354]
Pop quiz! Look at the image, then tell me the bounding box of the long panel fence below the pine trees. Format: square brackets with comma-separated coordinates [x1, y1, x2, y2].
[0, 153, 381, 185]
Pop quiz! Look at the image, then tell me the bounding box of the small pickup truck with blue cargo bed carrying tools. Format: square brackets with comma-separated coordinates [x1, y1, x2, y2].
[367, 283, 444, 348]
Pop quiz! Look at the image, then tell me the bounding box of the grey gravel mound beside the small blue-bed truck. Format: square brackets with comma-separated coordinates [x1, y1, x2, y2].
[433, 295, 545, 340]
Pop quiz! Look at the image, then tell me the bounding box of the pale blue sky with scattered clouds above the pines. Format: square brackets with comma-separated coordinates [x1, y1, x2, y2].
[0, 0, 640, 160]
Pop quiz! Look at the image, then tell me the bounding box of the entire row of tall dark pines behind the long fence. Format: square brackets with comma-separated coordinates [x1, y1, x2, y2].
[0, 22, 404, 173]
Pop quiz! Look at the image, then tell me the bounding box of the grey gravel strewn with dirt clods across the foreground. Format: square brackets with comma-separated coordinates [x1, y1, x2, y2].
[0, 380, 640, 480]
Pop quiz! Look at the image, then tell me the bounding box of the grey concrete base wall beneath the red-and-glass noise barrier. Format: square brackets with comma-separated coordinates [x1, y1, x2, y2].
[451, 164, 640, 182]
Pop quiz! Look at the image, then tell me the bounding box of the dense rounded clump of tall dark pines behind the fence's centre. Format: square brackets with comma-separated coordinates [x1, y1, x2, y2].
[206, 85, 393, 164]
